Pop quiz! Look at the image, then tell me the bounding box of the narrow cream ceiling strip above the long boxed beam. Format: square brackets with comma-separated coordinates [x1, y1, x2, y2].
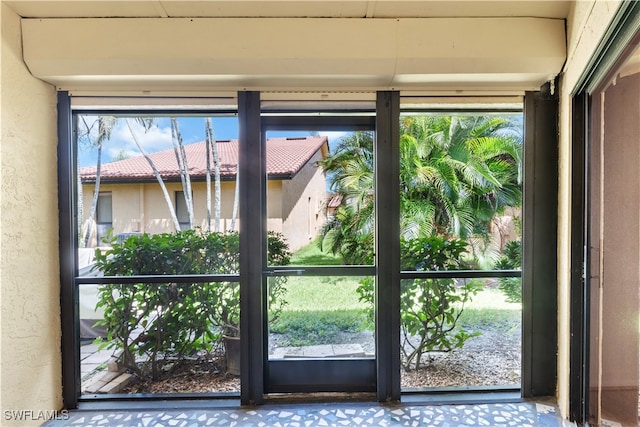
[4, 0, 572, 19]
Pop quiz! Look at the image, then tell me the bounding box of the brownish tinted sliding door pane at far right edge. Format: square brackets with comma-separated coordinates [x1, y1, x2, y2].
[588, 41, 640, 426]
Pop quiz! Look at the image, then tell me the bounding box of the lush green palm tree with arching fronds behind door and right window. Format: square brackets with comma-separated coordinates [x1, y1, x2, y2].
[321, 115, 522, 266]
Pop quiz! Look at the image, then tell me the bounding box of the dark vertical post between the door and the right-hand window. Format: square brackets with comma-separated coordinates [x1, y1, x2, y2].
[374, 91, 400, 402]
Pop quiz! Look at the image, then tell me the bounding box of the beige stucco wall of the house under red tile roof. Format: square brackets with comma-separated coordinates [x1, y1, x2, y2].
[82, 179, 318, 250]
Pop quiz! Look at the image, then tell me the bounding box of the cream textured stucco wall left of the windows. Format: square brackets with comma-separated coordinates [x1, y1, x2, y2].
[0, 4, 62, 426]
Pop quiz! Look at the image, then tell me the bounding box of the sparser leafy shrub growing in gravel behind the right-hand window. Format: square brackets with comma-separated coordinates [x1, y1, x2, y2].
[358, 236, 481, 370]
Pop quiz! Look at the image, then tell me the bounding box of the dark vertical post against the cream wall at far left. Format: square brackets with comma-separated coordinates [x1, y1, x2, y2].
[58, 92, 80, 409]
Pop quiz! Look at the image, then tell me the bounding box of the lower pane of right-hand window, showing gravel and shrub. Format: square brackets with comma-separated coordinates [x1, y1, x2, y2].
[401, 278, 522, 390]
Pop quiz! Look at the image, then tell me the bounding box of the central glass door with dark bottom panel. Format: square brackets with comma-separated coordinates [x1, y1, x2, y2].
[262, 113, 376, 393]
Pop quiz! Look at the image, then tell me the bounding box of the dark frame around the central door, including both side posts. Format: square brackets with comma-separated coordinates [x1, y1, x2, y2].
[238, 92, 400, 404]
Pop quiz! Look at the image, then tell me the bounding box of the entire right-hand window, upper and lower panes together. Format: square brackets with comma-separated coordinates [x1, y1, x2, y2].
[400, 113, 523, 389]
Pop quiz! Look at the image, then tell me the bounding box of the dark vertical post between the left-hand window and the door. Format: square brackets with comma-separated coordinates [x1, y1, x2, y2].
[238, 92, 264, 405]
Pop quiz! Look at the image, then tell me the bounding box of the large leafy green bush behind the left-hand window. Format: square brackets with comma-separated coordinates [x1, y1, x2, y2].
[96, 230, 290, 379]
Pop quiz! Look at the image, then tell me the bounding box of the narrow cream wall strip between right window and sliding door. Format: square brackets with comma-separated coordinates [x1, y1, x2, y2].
[557, 0, 621, 417]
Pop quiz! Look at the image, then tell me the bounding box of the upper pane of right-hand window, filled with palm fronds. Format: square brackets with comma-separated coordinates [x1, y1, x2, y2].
[400, 114, 523, 270]
